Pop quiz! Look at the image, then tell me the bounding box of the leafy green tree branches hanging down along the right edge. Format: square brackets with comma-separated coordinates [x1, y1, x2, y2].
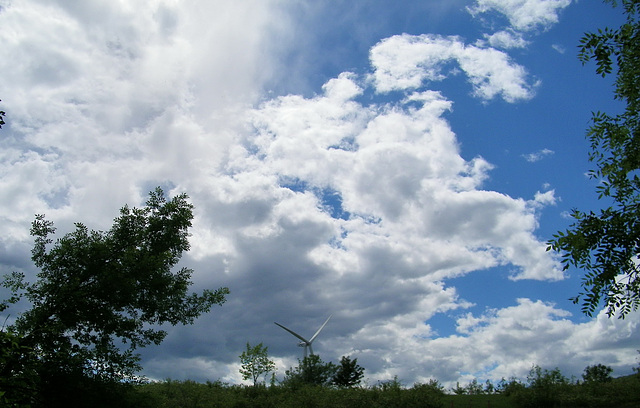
[548, 0, 640, 318]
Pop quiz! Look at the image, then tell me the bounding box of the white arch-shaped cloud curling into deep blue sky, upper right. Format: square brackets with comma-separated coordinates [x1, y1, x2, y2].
[370, 34, 538, 102]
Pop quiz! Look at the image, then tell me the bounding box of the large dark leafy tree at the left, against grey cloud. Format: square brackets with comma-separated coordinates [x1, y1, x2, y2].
[3, 188, 229, 391]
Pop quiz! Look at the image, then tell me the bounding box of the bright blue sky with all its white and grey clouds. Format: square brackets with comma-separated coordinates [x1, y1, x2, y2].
[0, 0, 640, 386]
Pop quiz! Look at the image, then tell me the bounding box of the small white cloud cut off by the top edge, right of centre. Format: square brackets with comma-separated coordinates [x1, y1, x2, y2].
[468, 0, 571, 31]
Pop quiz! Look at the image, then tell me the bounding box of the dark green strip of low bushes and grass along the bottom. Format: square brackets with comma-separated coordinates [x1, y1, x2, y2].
[131, 365, 640, 408]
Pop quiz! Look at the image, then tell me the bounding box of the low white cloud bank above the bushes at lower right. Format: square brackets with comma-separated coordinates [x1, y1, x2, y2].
[322, 298, 640, 387]
